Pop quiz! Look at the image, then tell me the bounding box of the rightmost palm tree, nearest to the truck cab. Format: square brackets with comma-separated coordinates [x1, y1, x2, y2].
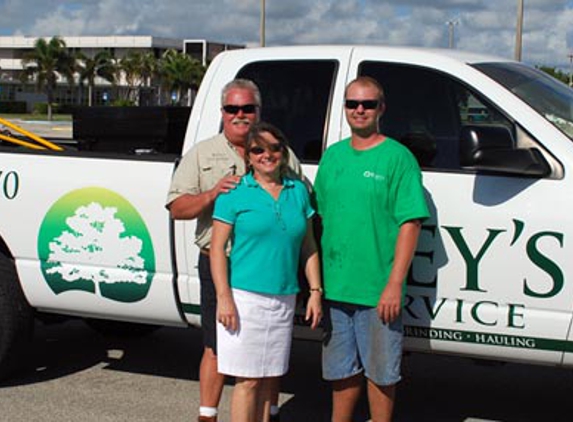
[160, 49, 205, 104]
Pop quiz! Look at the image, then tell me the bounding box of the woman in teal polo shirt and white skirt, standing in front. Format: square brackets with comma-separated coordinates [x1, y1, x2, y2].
[210, 123, 322, 422]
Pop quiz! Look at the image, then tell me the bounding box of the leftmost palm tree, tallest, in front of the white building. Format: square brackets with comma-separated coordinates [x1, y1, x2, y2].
[22, 37, 75, 120]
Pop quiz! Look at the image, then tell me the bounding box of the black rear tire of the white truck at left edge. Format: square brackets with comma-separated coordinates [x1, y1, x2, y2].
[0, 253, 34, 379]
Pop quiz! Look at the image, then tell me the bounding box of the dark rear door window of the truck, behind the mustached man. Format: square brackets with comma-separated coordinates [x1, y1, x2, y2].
[237, 60, 338, 163]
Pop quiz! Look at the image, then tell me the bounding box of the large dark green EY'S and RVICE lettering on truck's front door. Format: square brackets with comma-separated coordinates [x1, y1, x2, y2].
[404, 219, 565, 334]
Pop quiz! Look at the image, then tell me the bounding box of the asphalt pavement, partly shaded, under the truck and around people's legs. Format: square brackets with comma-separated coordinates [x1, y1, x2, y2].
[0, 321, 573, 422]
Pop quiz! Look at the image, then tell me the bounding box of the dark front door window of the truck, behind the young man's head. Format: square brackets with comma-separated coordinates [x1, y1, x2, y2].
[359, 62, 514, 170]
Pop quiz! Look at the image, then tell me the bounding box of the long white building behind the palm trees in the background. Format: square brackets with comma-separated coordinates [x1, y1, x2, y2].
[0, 36, 244, 111]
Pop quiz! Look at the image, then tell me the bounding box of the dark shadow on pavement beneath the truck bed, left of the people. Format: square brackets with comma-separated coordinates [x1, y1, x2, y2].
[0, 320, 202, 387]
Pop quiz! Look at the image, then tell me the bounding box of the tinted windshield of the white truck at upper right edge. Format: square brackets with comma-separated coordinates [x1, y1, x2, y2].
[473, 63, 573, 140]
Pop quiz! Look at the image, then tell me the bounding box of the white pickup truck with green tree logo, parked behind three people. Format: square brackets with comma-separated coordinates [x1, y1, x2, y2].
[0, 46, 573, 375]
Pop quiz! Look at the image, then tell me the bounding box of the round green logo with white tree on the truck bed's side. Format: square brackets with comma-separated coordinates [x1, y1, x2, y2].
[38, 187, 155, 302]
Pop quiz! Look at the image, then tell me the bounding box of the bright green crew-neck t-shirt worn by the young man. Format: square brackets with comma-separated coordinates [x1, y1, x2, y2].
[314, 138, 429, 306]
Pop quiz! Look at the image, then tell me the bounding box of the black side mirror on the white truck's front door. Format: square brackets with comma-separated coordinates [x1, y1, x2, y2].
[460, 125, 551, 177]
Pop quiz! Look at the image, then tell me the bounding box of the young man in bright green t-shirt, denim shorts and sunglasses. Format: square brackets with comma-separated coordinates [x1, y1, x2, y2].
[315, 77, 429, 422]
